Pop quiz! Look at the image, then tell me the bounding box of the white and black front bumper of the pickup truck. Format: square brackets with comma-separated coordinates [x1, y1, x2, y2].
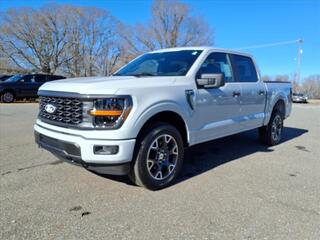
[34, 124, 135, 175]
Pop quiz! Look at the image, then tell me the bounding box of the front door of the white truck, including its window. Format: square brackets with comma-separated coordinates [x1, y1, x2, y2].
[193, 52, 241, 142]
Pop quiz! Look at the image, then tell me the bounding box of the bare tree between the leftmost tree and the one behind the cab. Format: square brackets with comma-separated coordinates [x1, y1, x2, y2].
[64, 7, 120, 76]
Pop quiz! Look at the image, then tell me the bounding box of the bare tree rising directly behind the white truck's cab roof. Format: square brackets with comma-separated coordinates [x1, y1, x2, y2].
[122, 0, 213, 55]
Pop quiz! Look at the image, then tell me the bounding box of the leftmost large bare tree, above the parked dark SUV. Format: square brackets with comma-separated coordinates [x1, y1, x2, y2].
[0, 7, 72, 73]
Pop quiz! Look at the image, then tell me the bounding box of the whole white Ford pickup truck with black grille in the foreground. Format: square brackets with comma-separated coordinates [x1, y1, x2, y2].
[34, 47, 292, 190]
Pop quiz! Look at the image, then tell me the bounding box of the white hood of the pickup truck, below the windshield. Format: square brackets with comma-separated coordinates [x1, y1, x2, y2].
[39, 76, 178, 95]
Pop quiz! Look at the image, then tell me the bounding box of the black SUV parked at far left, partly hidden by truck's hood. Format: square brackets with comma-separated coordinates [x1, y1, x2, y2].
[0, 74, 65, 103]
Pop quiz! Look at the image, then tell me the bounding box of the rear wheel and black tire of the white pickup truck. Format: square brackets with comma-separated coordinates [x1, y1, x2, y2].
[259, 110, 283, 146]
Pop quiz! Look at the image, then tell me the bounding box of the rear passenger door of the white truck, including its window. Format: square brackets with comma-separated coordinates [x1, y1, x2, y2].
[230, 54, 266, 130]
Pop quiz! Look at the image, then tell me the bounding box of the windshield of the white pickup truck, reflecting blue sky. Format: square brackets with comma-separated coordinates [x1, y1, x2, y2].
[114, 50, 202, 77]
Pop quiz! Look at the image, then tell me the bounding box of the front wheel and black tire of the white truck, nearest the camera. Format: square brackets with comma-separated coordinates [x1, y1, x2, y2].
[129, 123, 184, 190]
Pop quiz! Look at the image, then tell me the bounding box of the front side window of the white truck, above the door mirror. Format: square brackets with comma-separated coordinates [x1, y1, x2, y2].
[197, 53, 234, 82]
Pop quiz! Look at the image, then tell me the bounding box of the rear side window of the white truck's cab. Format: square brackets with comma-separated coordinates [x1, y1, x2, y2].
[231, 54, 258, 82]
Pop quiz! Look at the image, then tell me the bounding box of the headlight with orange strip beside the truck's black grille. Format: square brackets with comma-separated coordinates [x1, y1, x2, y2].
[89, 96, 132, 129]
